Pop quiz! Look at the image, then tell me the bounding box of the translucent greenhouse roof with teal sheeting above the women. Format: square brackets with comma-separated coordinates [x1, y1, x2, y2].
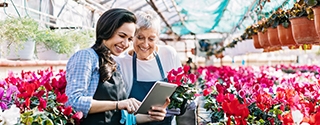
[82, 0, 296, 36]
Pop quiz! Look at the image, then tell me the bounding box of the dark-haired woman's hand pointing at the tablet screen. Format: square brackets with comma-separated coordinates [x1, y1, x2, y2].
[118, 98, 141, 114]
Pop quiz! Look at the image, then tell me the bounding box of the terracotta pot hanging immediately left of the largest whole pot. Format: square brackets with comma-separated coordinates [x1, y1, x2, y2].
[277, 24, 297, 46]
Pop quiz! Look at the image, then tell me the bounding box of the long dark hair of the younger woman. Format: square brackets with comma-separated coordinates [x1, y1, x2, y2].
[92, 8, 136, 82]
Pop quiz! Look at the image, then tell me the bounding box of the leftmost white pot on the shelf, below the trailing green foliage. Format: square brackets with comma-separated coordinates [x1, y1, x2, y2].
[6, 40, 35, 60]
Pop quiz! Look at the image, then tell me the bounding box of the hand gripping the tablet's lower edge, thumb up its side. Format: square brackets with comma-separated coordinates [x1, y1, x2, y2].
[148, 98, 170, 121]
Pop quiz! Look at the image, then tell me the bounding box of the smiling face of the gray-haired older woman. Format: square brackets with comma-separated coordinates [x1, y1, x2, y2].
[133, 28, 159, 60]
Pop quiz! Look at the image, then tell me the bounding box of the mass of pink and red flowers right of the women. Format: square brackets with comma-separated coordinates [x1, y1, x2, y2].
[197, 65, 320, 125]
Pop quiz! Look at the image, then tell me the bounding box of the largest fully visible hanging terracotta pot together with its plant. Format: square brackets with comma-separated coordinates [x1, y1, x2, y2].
[290, 0, 320, 44]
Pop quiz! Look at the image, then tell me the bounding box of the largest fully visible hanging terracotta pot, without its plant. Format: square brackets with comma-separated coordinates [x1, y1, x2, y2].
[290, 17, 320, 44]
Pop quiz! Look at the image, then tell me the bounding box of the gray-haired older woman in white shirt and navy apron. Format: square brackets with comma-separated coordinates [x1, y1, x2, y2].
[115, 11, 181, 125]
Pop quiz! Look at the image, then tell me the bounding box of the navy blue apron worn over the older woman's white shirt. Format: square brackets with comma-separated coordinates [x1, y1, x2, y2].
[129, 52, 173, 125]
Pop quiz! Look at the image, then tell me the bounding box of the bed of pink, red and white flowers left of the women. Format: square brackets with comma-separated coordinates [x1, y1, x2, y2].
[0, 68, 82, 125]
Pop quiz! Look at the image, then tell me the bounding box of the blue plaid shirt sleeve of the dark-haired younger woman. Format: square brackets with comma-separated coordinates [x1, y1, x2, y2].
[66, 48, 100, 117]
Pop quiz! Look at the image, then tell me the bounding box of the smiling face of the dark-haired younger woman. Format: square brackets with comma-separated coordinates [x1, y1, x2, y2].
[103, 23, 135, 56]
